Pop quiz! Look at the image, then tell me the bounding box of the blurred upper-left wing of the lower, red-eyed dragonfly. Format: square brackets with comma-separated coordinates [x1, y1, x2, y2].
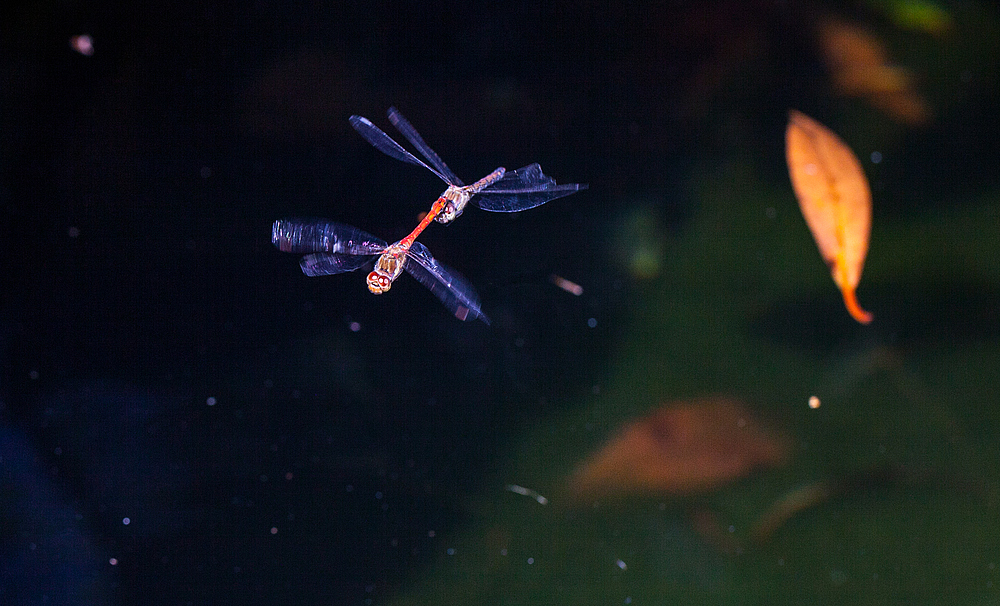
[271, 219, 386, 255]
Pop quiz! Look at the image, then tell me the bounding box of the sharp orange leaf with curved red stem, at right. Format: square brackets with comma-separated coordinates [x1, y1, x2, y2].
[785, 110, 872, 324]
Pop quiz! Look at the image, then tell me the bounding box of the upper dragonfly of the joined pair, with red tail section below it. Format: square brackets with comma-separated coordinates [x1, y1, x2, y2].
[350, 107, 587, 238]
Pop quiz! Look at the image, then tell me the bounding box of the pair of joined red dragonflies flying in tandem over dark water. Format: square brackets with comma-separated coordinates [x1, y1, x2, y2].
[271, 107, 587, 324]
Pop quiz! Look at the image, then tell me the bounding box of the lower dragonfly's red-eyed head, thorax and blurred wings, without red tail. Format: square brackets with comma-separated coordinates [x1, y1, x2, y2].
[271, 219, 490, 324]
